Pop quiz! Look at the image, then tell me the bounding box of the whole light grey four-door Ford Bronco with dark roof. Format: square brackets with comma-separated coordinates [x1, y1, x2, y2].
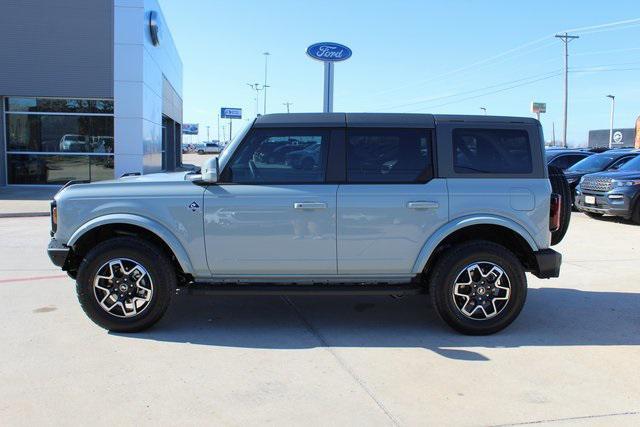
[48, 113, 570, 335]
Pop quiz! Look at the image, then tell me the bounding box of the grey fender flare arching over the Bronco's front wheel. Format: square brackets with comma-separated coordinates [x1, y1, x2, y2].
[67, 214, 193, 273]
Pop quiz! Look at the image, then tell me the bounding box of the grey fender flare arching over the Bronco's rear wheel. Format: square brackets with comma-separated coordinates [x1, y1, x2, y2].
[412, 215, 538, 274]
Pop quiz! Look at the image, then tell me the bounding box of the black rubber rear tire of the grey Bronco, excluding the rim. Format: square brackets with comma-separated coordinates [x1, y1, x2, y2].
[429, 240, 527, 335]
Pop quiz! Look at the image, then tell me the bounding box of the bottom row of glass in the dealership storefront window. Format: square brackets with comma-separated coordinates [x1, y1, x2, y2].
[7, 154, 113, 185]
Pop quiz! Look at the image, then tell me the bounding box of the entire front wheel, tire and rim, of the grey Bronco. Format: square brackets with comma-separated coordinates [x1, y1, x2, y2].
[76, 237, 176, 332]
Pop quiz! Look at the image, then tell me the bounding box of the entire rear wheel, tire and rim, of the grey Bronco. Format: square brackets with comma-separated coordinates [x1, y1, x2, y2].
[429, 241, 527, 335]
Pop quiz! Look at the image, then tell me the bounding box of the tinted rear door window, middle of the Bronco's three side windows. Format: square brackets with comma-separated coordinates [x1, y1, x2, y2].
[347, 128, 433, 183]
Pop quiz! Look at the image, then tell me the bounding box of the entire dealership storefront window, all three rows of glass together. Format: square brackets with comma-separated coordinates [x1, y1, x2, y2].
[4, 97, 114, 185]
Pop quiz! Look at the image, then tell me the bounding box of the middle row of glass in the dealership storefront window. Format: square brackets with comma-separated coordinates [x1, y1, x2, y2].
[6, 114, 113, 153]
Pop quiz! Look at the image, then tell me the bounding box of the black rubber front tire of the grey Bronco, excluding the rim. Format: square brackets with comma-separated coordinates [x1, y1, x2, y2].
[76, 237, 176, 332]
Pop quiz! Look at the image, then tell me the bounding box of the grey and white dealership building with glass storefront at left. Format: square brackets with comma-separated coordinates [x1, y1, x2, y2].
[0, 0, 182, 186]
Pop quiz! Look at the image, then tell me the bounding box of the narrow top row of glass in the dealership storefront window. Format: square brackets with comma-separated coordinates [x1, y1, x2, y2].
[6, 97, 113, 114]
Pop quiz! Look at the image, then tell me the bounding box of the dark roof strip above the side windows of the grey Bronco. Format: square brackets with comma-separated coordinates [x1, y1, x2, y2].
[254, 113, 538, 128]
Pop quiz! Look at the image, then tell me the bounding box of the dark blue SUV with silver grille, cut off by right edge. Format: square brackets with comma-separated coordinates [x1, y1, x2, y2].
[576, 151, 640, 224]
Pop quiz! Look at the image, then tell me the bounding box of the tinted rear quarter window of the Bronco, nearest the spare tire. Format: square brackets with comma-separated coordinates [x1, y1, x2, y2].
[452, 128, 533, 174]
